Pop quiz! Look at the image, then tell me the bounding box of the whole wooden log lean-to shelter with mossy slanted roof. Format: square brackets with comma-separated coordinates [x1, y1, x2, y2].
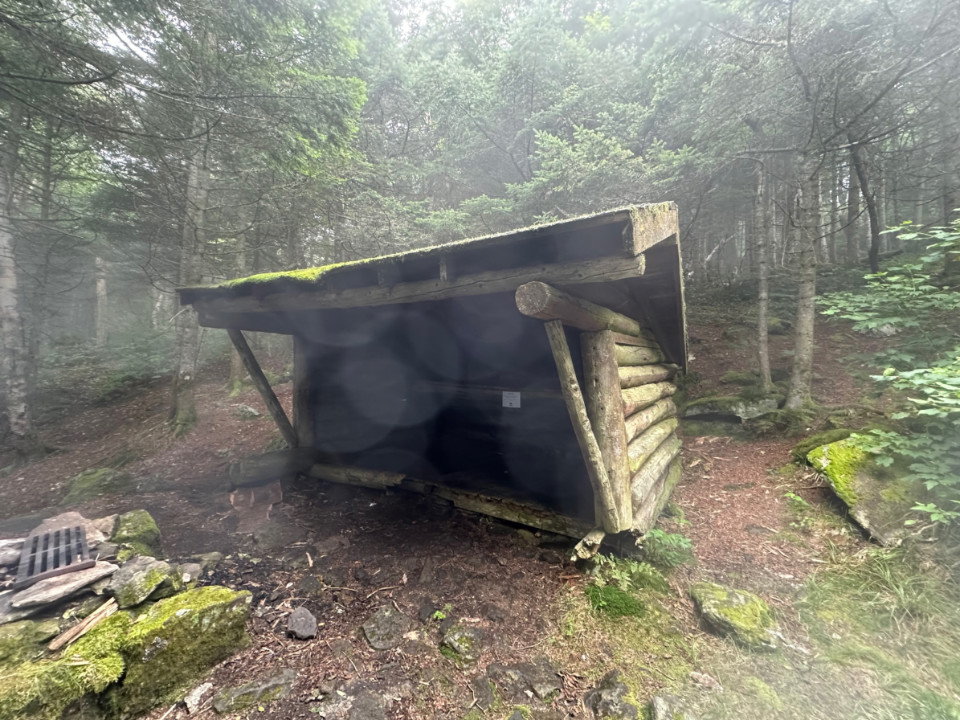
[180, 203, 686, 537]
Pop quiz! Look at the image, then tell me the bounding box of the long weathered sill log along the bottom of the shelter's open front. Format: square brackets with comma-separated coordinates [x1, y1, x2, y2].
[307, 465, 590, 538]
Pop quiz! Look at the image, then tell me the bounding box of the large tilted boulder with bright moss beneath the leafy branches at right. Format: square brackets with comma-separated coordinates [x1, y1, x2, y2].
[807, 439, 924, 547]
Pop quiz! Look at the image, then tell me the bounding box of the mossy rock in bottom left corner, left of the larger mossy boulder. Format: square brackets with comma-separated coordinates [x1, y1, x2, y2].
[0, 612, 131, 720]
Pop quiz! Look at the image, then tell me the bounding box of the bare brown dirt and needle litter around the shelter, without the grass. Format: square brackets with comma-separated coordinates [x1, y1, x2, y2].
[0, 300, 936, 720]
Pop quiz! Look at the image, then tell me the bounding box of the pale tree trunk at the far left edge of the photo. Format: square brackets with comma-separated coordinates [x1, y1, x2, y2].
[0, 142, 38, 457]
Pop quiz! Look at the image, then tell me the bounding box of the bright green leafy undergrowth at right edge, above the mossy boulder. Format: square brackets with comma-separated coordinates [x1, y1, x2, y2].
[821, 220, 960, 523]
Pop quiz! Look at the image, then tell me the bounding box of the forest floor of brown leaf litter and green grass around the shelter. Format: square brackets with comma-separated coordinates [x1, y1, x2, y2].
[0, 290, 960, 720]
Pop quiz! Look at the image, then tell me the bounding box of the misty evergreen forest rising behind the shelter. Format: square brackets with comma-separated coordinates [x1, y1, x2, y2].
[0, 0, 960, 466]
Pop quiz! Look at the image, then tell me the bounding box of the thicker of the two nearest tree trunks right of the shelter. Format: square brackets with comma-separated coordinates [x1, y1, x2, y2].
[785, 153, 820, 410]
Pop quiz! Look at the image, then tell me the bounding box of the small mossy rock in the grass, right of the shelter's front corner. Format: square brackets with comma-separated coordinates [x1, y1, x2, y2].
[690, 582, 779, 650]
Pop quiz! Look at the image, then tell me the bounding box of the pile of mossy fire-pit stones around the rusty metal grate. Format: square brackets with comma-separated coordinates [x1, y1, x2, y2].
[0, 510, 251, 720]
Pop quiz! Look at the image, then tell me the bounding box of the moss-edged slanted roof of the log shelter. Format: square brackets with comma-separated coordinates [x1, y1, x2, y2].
[179, 203, 686, 364]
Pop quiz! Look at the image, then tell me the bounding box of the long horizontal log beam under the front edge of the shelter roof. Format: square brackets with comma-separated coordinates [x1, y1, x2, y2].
[194, 256, 644, 325]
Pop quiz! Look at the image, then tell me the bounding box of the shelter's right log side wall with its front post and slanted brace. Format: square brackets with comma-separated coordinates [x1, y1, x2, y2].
[516, 282, 681, 533]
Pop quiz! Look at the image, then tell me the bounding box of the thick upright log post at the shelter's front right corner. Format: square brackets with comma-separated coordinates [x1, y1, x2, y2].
[580, 332, 633, 527]
